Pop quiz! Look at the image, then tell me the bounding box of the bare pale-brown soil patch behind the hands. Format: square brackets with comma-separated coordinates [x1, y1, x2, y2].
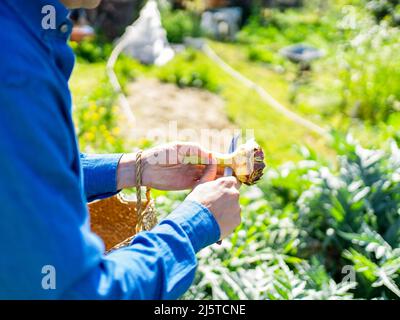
[123, 78, 235, 150]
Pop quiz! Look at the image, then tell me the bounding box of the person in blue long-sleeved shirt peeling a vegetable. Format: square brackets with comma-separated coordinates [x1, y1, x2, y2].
[0, 0, 240, 299]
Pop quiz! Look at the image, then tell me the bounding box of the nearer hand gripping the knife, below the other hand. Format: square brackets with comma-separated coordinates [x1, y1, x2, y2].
[187, 177, 241, 239]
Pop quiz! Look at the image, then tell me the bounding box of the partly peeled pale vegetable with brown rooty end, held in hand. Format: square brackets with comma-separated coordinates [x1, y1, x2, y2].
[214, 140, 265, 185]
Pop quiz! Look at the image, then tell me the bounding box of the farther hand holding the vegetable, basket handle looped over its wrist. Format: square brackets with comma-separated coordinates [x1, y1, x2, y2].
[117, 143, 223, 190]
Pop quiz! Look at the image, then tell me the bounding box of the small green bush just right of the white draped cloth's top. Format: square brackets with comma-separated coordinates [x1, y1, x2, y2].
[161, 8, 201, 43]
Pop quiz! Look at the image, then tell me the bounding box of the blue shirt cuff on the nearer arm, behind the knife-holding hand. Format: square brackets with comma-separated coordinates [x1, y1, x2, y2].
[160, 200, 221, 253]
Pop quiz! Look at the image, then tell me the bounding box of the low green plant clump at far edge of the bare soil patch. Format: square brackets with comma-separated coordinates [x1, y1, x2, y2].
[156, 50, 219, 92]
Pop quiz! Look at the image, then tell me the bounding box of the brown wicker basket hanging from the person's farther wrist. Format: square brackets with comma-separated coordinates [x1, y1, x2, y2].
[88, 188, 157, 252]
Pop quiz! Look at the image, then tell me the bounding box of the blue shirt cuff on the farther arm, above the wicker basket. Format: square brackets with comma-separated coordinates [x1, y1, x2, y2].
[81, 153, 123, 201]
